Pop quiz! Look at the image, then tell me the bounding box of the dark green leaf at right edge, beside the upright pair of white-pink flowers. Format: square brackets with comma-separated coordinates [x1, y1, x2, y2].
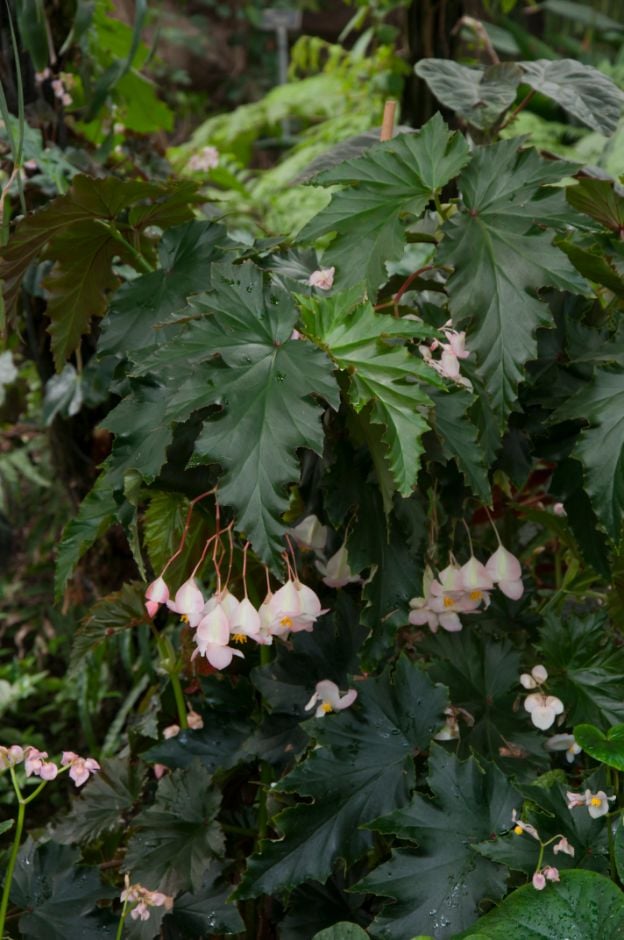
[539, 611, 624, 730]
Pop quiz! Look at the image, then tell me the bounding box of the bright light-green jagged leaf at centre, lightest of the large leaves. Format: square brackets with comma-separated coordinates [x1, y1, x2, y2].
[299, 290, 442, 496]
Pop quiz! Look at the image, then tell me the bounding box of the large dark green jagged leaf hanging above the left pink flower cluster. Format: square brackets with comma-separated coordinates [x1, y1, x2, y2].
[133, 262, 339, 564]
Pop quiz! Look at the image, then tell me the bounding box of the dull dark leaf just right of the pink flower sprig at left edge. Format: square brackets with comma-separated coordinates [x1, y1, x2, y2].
[54, 758, 146, 844]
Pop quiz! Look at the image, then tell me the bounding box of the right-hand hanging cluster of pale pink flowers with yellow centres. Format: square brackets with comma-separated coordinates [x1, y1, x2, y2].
[409, 545, 524, 633]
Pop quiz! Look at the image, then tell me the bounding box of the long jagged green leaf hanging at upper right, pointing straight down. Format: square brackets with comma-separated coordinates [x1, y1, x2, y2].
[438, 140, 585, 427]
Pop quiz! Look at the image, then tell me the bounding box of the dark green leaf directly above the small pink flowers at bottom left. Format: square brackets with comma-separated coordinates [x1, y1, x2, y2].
[124, 762, 223, 895]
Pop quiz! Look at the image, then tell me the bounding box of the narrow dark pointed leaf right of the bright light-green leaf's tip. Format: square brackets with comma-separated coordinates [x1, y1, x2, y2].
[430, 388, 491, 505]
